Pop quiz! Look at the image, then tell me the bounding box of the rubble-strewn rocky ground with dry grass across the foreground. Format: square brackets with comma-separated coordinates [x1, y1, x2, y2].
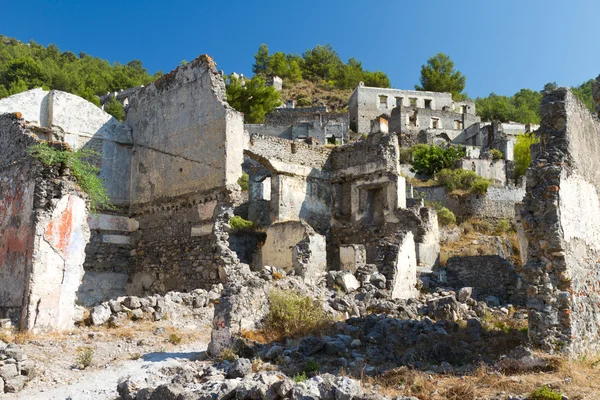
[0, 269, 600, 400]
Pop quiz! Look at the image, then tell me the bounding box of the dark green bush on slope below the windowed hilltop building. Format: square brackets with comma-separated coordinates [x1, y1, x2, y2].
[411, 144, 467, 176]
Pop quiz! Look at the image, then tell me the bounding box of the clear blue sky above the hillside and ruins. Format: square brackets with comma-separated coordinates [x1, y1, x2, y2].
[0, 0, 600, 97]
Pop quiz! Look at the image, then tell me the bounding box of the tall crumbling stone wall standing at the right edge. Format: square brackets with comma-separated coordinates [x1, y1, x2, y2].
[521, 88, 600, 354]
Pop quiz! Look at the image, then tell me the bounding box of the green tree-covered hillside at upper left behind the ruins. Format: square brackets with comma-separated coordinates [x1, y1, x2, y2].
[0, 35, 162, 105]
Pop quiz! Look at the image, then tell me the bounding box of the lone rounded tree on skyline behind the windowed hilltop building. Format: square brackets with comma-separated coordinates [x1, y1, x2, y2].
[415, 53, 467, 101]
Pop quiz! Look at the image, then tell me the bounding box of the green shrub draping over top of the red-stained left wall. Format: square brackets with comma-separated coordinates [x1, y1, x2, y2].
[27, 142, 115, 212]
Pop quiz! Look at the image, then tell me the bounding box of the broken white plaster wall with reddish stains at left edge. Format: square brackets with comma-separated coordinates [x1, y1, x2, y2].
[0, 113, 89, 330]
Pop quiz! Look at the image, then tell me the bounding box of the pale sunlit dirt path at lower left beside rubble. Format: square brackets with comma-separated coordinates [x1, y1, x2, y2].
[3, 341, 207, 400]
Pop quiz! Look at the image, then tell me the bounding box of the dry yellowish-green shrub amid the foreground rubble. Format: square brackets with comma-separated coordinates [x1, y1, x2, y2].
[264, 289, 332, 339]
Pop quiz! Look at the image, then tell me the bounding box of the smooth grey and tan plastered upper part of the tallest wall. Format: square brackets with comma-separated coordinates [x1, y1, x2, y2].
[127, 56, 245, 206]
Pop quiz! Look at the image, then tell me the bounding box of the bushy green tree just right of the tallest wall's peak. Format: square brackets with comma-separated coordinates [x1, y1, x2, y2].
[227, 75, 281, 124]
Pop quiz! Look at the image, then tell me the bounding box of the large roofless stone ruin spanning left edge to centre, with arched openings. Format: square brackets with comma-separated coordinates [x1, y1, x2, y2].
[0, 56, 438, 330]
